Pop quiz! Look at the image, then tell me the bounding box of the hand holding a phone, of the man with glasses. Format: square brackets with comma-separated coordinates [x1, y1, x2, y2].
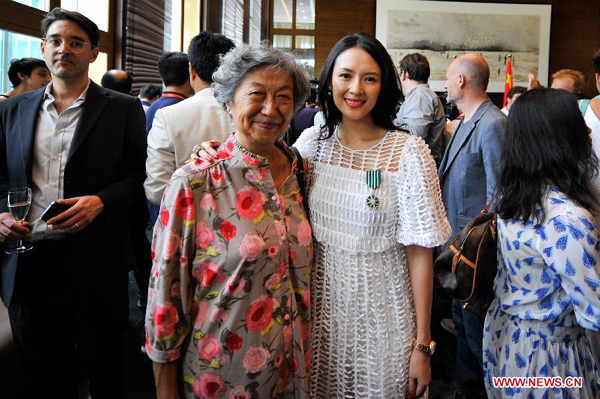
[47, 195, 104, 233]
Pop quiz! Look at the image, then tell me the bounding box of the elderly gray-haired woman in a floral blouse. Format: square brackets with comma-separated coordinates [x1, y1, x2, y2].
[146, 44, 313, 399]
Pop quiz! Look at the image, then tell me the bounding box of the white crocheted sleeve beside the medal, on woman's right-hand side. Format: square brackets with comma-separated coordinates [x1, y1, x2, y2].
[397, 136, 452, 248]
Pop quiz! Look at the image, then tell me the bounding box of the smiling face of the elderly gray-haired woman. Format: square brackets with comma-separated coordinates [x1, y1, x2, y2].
[227, 68, 294, 155]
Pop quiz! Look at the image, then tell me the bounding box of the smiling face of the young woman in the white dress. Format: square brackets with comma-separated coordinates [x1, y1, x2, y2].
[331, 47, 381, 123]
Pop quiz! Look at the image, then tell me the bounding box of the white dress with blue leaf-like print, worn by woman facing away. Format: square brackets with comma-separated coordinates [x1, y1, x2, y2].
[483, 188, 600, 399]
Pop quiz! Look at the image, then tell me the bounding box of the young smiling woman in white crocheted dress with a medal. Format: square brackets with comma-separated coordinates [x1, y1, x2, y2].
[197, 33, 451, 399]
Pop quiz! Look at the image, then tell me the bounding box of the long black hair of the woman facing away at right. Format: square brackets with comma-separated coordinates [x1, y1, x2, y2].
[497, 88, 598, 223]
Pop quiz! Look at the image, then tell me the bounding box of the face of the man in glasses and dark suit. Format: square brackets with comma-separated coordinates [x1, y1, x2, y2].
[42, 20, 99, 80]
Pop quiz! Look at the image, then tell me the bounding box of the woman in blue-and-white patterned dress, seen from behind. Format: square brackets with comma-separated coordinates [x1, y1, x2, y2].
[483, 89, 600, 399]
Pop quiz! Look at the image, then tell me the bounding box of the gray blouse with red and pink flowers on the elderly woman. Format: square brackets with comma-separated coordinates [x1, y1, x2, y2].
[146, 135, 313, 399]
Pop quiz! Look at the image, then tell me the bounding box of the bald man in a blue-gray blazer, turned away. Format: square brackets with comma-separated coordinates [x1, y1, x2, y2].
[438, 53, 506, 398]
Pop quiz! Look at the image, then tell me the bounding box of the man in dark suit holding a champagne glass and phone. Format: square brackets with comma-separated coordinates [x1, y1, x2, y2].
[0, 8, 146, 398]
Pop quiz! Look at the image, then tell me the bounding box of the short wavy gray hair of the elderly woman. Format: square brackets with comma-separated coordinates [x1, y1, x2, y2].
[212, 41, 310, 113]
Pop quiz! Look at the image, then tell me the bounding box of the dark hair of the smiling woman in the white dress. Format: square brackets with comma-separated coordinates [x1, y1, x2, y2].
[317, 32, 402, 138]
